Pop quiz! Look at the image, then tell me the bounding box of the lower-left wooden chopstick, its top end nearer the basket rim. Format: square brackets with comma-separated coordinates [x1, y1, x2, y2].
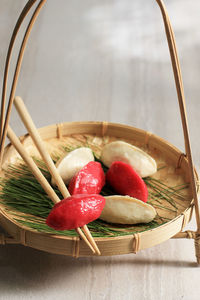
[7, 126, 95, 253]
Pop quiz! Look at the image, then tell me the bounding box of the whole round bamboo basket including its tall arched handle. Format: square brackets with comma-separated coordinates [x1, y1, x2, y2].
[0, 0, 200, 264]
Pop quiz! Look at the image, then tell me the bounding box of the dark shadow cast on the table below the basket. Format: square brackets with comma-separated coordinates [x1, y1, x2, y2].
[0, 245, 197, 292]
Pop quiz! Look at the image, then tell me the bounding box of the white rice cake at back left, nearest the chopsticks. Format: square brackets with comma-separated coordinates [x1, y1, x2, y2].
[52, 147, 94, 185]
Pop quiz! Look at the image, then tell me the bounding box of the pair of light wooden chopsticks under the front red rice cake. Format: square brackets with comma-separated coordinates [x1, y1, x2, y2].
[7, 97, 101, 255]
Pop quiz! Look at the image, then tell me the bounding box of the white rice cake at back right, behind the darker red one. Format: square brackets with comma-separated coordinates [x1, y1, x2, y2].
[101, 141, 157, 177]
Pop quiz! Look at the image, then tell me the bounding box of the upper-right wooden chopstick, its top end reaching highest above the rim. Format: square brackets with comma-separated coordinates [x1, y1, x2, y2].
[14, 97, 101, 255]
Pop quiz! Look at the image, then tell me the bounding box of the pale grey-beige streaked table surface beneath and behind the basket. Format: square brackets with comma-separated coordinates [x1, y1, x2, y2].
[0, 0, 200, 300]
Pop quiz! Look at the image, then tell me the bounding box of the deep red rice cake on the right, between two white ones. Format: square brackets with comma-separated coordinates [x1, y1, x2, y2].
[106, 161, 148, 202]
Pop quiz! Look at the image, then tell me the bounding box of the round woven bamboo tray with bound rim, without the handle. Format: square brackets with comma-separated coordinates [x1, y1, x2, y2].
[0, 122, 197, 256]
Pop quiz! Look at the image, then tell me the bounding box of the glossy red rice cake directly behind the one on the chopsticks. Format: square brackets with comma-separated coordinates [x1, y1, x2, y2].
[68, 161, 105, 195]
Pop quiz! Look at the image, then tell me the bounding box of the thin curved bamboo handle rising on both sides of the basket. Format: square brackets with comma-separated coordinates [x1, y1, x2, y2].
[0, 0, 200, 234]
